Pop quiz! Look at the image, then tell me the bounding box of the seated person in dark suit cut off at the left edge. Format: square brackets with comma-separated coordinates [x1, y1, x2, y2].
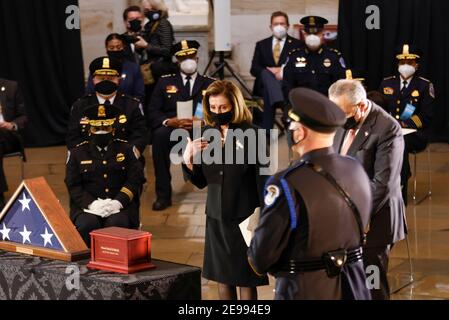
[0, 79, 27, 209]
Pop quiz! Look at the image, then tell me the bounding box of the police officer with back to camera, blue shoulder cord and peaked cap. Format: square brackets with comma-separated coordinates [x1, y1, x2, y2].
[248, 88, 371, 300]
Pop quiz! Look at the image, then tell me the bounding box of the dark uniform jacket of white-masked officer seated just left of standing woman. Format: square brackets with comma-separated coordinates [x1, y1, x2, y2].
[147, 73, 215, 130]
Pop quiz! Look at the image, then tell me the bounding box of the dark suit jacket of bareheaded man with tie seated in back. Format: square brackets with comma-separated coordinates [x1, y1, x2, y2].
[251, 36, 304, 97]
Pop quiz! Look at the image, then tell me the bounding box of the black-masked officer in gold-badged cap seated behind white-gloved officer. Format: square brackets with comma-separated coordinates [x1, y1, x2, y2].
[66, 57, 148, 155]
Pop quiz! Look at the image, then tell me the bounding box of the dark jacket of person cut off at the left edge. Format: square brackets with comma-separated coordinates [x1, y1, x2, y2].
[0, 79, 27, 131]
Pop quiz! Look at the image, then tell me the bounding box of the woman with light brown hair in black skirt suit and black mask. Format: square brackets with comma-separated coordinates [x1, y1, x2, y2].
[183, 81, 268, 300]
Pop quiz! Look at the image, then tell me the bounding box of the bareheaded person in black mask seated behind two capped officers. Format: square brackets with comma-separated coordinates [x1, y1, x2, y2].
[86, 33, 145, 103]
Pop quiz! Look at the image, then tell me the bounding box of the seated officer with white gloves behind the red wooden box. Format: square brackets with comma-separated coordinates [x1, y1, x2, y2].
[65, 105, 145, 246]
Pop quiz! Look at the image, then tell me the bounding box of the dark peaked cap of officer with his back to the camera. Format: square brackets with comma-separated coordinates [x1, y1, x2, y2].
[288, 88, 346, 133]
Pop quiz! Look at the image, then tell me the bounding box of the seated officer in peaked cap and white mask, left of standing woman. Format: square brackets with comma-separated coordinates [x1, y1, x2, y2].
[148, 40, 214, 211]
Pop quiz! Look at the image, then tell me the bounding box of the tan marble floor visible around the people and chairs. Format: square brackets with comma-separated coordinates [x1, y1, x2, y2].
[5, 140, 449, 300]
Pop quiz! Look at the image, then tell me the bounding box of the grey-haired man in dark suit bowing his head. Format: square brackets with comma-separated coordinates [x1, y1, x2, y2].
[329, 80, 406, 300]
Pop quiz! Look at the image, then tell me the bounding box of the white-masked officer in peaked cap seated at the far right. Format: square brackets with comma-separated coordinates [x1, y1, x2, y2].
[380, 44, 435, 204]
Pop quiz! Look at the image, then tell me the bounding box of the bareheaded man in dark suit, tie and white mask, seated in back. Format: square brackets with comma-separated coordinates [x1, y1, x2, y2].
[251, 11, 303, 130]
